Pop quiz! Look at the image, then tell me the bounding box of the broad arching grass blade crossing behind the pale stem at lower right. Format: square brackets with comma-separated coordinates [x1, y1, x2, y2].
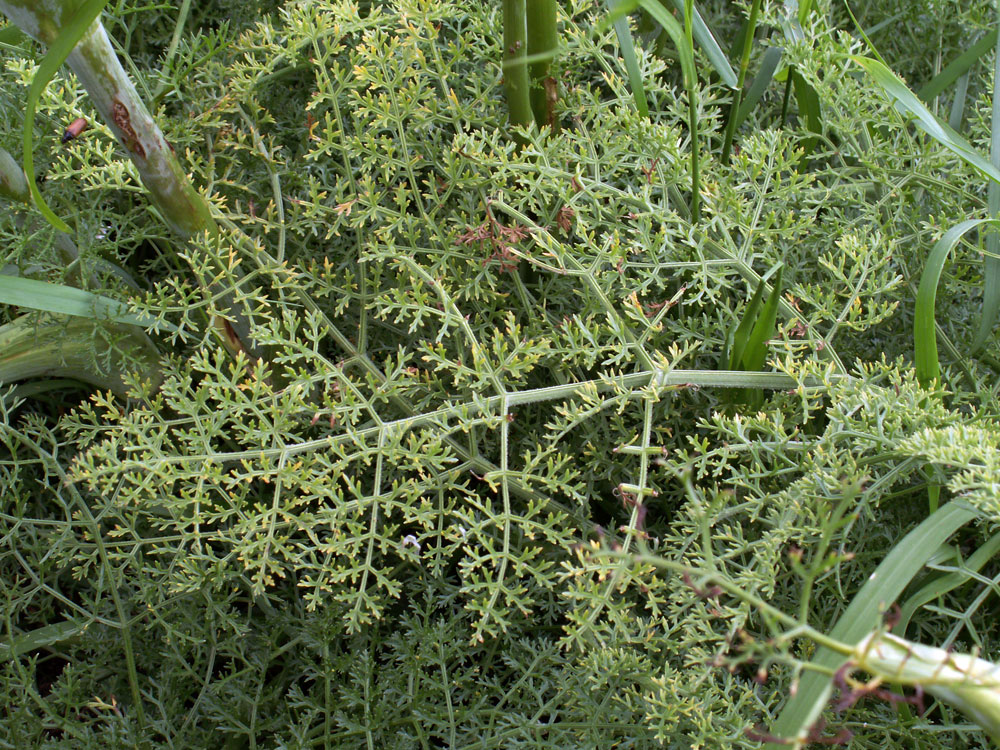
[765, 501, 976, 750]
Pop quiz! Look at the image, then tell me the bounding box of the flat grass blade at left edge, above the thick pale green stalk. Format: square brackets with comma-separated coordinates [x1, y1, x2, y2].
[0, 275, 177, 331]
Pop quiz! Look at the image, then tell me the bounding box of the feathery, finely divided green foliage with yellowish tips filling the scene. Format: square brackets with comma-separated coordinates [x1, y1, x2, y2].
[0, 0, 1000, 750]
